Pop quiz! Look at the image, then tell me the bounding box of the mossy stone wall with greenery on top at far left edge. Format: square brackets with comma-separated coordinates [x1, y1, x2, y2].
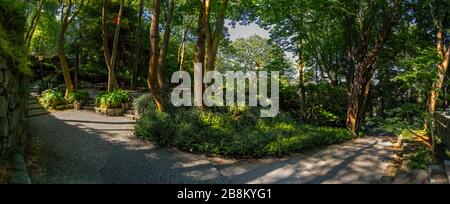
[0, 0, 30, 158]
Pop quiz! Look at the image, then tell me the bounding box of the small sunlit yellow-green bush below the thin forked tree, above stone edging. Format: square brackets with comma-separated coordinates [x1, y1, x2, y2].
[95, 89, 130, 108]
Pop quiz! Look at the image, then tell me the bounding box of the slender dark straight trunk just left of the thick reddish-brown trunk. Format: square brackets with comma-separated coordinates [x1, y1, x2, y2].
[131, 0, 144, 89]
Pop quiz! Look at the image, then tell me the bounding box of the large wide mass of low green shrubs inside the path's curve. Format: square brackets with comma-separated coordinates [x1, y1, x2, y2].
[135, 107, 352, 157]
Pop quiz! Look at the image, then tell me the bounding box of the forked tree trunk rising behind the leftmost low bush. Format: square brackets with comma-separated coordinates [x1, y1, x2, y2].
[56, 0, 84, 97]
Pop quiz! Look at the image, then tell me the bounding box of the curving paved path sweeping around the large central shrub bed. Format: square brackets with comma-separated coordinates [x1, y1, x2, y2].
[29, 110, 393, 184]
